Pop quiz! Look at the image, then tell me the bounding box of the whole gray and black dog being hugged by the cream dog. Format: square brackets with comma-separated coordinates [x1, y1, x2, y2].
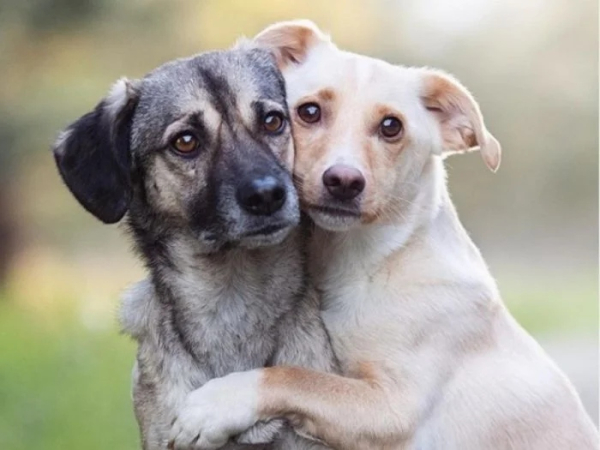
[54, 44, 335, 450]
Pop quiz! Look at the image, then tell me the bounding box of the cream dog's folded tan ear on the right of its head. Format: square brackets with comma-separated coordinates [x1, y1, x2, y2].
[421, 69, 501, 172]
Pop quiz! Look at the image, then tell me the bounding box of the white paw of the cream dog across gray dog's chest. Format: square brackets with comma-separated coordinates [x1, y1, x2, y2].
[169, 371, 260, 450]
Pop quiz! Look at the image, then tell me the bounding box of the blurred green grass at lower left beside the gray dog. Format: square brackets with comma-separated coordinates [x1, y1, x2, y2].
[0, 301, 139, 450]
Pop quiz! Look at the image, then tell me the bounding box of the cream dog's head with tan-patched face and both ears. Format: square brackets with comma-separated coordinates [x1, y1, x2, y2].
[255, 21, 500, 230]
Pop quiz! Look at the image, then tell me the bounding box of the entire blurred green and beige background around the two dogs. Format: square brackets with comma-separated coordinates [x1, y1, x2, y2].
[0, 0, 598, 450]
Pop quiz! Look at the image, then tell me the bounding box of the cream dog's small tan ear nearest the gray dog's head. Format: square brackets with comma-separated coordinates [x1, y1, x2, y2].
[254, 20, 331, 69]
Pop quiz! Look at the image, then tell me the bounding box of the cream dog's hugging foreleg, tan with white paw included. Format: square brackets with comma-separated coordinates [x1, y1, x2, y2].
[171, 367, 418, 450]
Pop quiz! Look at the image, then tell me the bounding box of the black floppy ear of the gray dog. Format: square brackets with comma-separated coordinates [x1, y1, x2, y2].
[53, 79, 138, 223]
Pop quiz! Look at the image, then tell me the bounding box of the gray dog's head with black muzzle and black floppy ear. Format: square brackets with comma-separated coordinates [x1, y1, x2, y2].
[54, 46, 299, 251]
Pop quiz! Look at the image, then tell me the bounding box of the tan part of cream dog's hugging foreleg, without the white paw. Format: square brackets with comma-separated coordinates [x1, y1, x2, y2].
[257, 367, 408, 450]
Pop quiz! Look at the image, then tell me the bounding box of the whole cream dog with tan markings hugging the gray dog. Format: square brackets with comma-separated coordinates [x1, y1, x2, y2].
[173, 22, 598, 450]
